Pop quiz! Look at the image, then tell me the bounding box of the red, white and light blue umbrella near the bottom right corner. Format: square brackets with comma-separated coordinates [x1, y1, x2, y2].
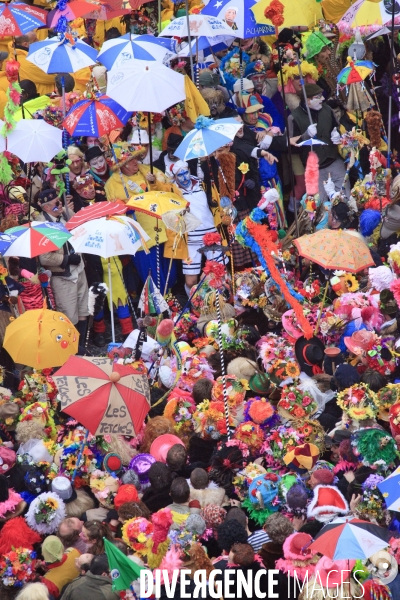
[309, 517, 392, 560]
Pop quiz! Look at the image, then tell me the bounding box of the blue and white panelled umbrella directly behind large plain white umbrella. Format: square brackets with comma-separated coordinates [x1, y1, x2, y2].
[97, 33, 176, 71]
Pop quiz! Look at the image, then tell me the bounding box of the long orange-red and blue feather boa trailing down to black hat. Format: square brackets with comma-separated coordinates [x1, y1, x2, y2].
[236, 208, 313, 339]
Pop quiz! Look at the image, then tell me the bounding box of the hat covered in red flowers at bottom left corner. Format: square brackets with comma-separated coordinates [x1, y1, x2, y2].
[0, 548, 37, 588]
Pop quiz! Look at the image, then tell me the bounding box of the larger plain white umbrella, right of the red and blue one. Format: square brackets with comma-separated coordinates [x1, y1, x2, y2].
[107, 60, 186, 113]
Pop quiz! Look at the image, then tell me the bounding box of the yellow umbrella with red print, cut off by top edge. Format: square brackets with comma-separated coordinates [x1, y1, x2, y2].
[250, 0, 323, 29]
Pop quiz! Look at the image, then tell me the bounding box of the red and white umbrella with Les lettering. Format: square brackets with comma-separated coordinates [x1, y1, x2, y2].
[53, 356, 150, 437]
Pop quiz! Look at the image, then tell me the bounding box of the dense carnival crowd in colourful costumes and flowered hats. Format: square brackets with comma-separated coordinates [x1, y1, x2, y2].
[0, 0, 400, 600]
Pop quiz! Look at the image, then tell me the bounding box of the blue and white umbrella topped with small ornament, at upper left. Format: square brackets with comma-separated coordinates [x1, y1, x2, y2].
[27, 34, 97, 73]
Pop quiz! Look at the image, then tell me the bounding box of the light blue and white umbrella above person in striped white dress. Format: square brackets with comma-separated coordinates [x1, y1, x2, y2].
[174, 116, 242, 160]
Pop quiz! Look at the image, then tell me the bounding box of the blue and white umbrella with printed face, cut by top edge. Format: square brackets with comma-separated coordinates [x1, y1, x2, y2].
[201, 0, 275, 39]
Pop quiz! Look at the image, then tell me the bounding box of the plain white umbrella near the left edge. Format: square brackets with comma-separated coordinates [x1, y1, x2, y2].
[7, 119, 62, 163]
